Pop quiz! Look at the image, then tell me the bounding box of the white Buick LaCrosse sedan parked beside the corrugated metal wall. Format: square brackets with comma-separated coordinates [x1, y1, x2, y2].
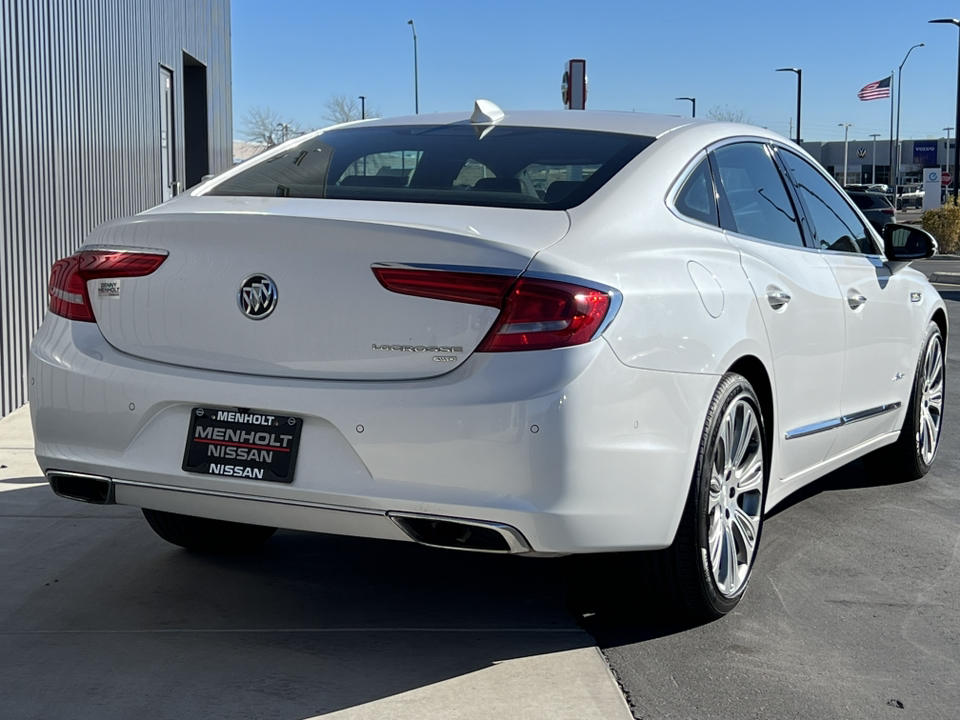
[30, 101, 947, 618]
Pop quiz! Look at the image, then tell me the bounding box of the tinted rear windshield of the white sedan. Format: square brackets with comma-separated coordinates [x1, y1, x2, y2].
[207, 123, 654, 210]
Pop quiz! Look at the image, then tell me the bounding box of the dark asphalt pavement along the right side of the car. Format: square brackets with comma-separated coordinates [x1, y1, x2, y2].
[585, 284, 960, 720]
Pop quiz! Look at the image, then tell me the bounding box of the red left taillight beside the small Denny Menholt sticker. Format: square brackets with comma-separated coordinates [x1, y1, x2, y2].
[47, 249, 167, 322]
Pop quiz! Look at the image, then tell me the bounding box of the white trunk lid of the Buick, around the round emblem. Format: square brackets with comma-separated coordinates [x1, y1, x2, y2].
[84, 213, 566, 380]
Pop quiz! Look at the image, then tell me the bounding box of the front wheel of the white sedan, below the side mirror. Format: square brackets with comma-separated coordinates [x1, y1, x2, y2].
[864, 322, 947, 481]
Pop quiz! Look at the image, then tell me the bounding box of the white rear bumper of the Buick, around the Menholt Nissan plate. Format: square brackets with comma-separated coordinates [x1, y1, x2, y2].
[30, 316, 718, 553]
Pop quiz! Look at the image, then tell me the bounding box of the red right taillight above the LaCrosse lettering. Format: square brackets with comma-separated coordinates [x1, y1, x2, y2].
[372, 266, 611, 352]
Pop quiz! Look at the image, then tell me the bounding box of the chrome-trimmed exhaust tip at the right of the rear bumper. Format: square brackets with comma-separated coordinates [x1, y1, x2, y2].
[387, 512, 533, 555]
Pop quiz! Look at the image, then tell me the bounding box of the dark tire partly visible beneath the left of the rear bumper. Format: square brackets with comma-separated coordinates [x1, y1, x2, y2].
[143, 508, 277, 554]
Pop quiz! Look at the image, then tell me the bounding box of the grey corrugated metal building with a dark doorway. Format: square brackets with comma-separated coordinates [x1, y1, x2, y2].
[0, 0, 233, 416]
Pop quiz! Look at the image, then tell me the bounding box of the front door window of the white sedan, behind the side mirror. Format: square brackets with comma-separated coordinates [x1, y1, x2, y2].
[780, 151, 877, 254]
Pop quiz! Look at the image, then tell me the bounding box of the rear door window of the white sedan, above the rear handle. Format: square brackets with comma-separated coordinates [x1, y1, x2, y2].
[713, 143, 803, 247]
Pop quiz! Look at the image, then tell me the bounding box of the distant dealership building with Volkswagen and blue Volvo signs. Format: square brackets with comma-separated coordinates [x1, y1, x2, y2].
[803, 137, 956, 185]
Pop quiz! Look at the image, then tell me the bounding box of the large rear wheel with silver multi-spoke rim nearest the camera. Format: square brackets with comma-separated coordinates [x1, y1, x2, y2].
[637, 373, 769, 620]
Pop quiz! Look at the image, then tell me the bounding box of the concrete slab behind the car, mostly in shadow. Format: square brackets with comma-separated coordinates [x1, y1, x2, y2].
[0, 408, 632, 720]
